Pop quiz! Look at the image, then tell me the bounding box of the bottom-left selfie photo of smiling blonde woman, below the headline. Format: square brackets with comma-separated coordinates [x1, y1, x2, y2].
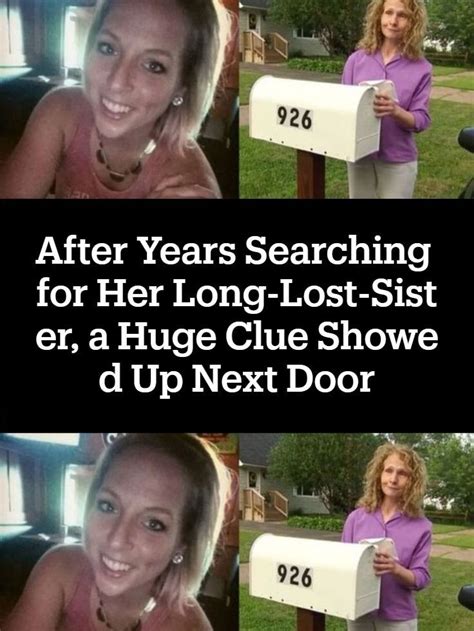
[0, 433, 238, 631]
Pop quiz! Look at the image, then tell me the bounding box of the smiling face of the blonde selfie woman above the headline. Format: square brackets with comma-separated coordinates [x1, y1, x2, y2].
[85, 0, 188, 138]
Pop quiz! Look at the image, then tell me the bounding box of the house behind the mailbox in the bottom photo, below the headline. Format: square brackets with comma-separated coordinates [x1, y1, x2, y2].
[239, 433, 328, 518]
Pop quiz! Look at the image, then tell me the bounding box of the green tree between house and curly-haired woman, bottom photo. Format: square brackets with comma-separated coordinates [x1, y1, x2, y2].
[269, 433, 385, 513]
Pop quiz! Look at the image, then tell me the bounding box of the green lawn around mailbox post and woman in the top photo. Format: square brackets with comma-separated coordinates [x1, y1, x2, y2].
[240, 100, 474, 199]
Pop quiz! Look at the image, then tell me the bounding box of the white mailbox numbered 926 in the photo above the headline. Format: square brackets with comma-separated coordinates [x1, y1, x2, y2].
[249, 75, 380, 162]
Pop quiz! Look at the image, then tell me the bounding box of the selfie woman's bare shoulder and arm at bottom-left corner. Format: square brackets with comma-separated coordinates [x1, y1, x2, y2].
[2, 546, 87, 631]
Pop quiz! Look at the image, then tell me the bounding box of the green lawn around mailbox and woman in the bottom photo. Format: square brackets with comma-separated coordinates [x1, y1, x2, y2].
[239, 558, 474, 631]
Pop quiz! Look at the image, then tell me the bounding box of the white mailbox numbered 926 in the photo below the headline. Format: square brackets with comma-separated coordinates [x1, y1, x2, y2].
[249, 534, 380, 620]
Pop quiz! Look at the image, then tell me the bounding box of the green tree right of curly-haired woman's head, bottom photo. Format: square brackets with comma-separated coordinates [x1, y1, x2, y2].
[428, 434, 474, 514]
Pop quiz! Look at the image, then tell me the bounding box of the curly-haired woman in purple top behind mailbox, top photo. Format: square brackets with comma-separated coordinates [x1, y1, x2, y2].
[342, 0, 432, 199]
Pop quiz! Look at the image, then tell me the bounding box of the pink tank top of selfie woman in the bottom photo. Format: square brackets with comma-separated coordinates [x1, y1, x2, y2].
[60, 566, 168, 631]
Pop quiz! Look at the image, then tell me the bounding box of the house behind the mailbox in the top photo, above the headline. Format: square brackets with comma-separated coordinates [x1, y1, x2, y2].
[239, 0, 329, 61]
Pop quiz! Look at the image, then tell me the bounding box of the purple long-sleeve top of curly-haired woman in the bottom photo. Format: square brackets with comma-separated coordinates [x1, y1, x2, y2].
[342, 508, 431, 621]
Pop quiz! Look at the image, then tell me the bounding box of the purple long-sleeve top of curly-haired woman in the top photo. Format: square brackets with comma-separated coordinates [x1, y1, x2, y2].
[342, 49, 432, 162]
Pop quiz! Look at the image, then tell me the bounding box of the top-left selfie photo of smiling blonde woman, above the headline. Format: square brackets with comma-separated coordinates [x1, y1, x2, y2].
[0, 0, 238, 199]
